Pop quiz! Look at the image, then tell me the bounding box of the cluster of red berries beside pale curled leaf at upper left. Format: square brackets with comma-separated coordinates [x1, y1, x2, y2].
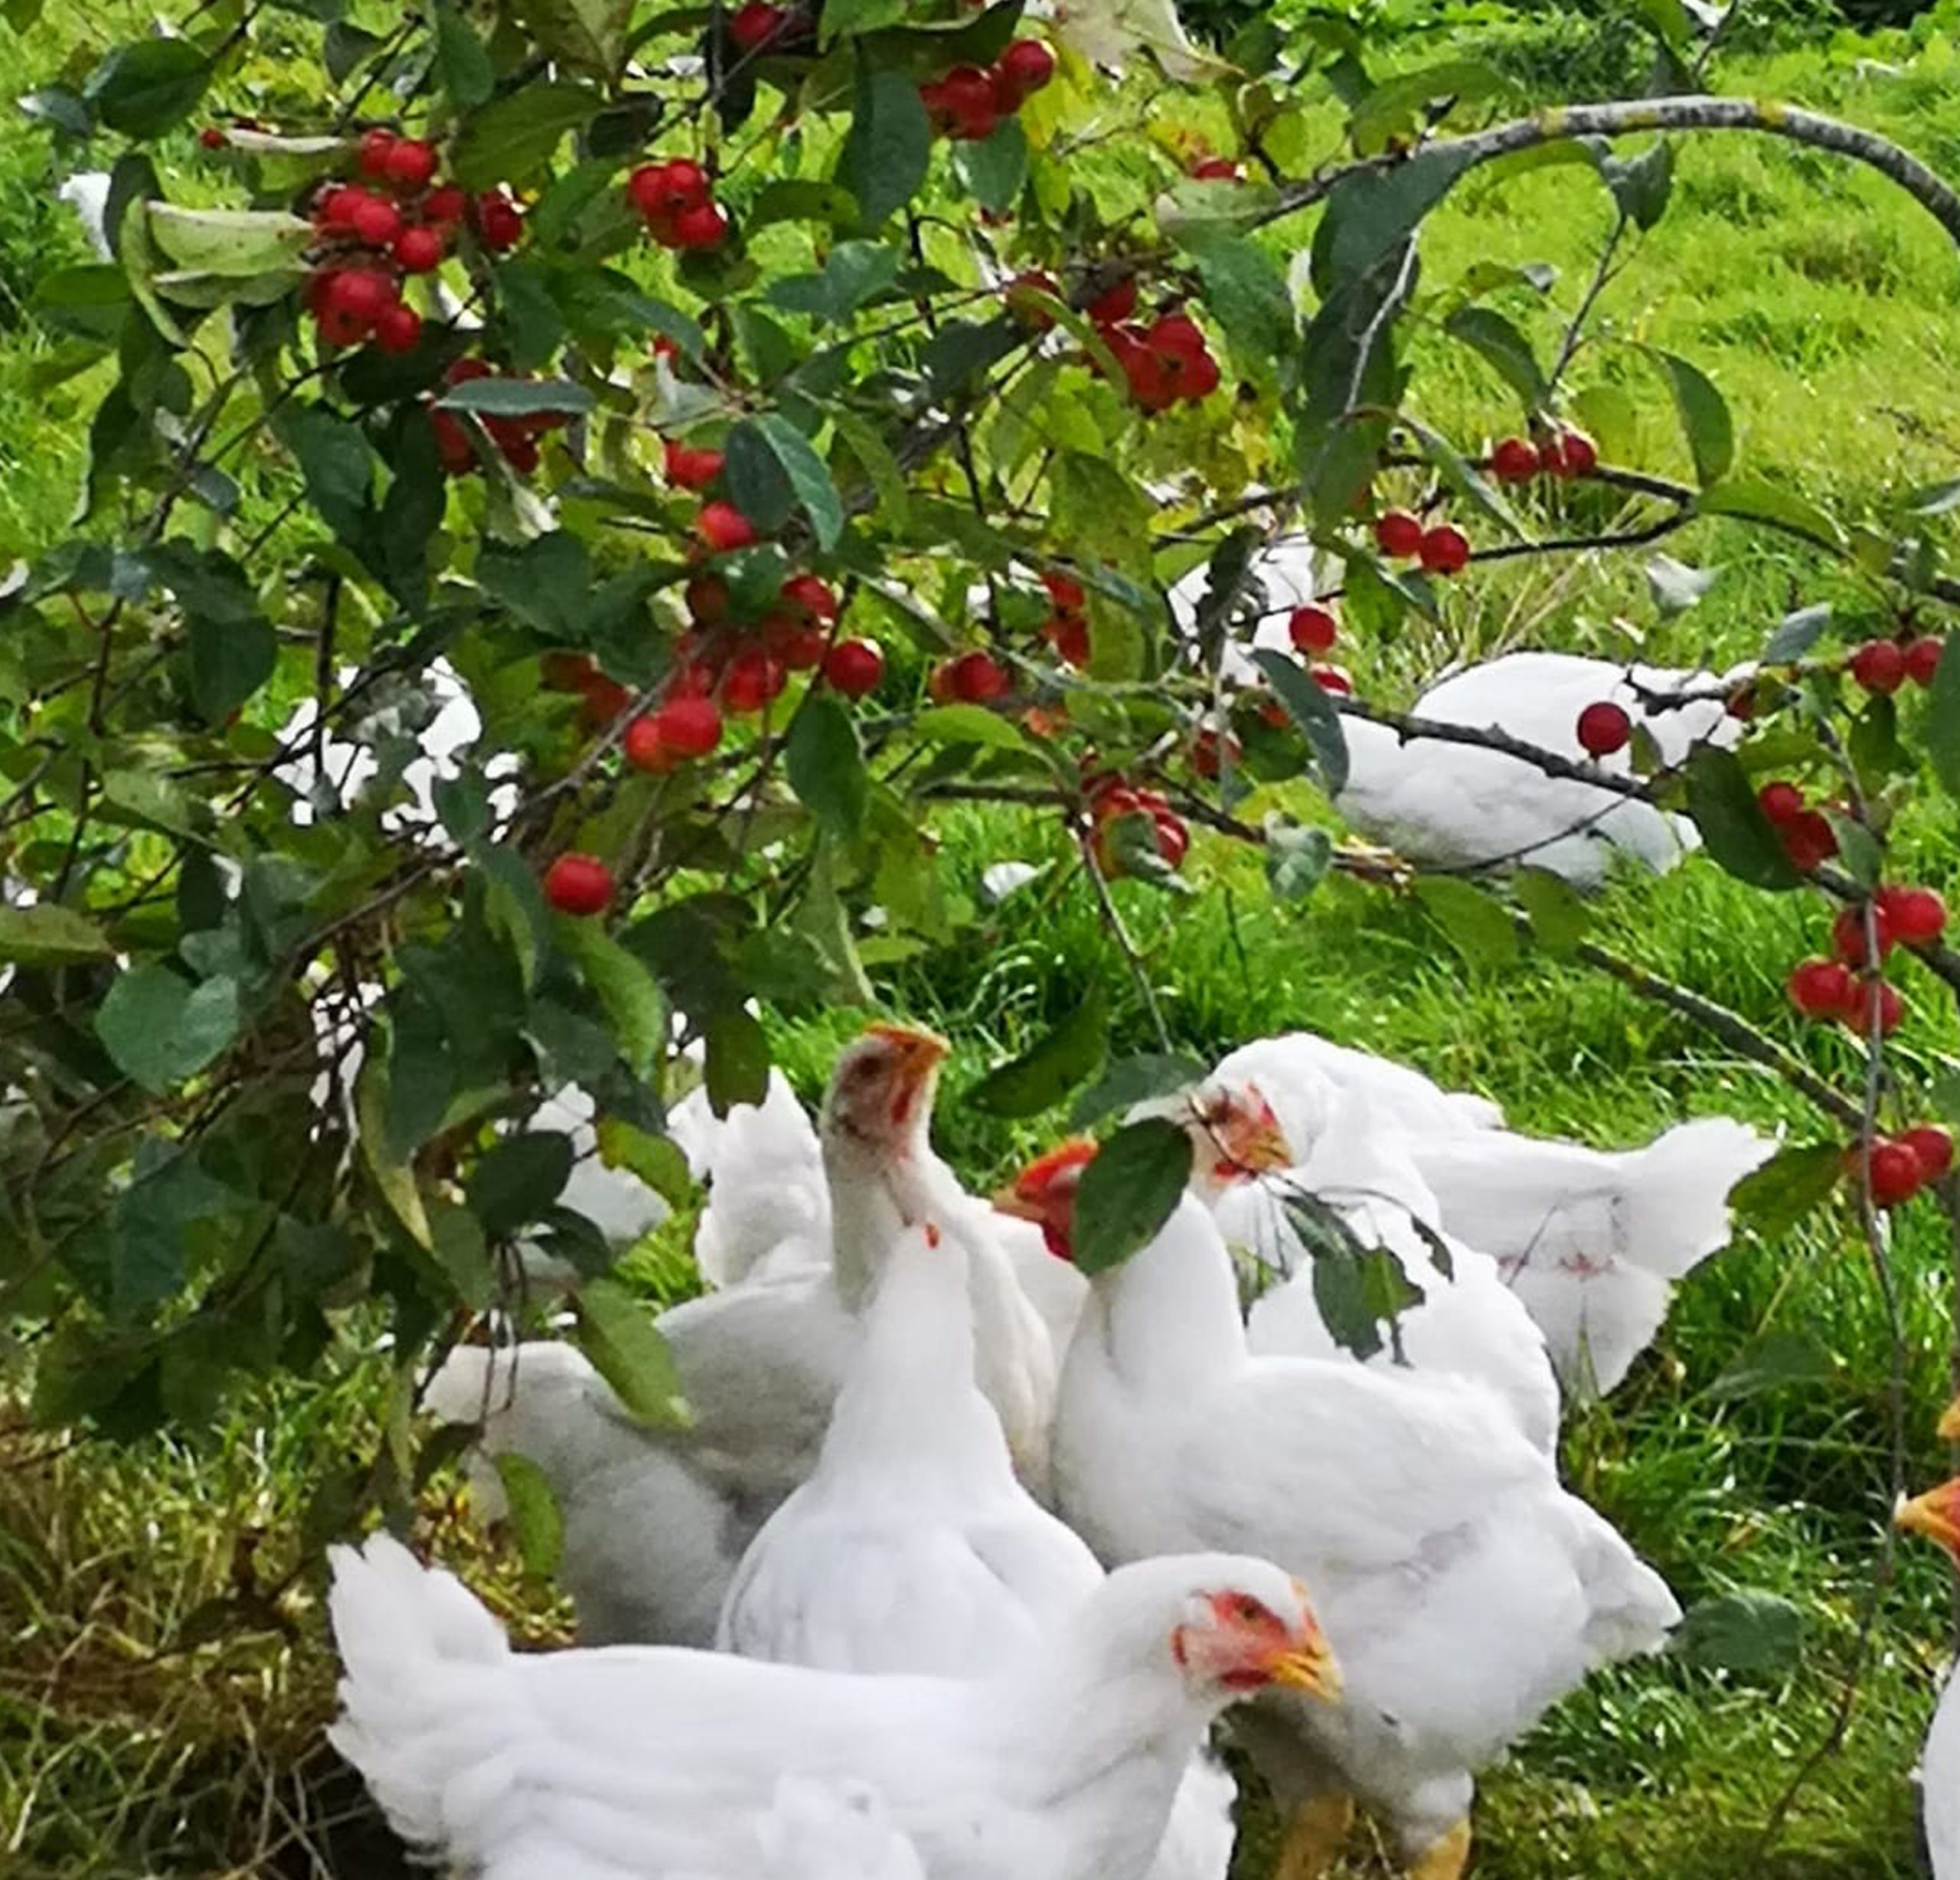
[305, 129, 524, 353]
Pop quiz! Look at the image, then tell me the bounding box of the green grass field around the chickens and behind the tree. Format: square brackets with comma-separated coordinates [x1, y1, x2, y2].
[0, 8, 1960, 1880]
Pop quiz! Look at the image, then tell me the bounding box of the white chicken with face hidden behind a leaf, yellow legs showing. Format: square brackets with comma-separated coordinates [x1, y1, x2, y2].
[1014, 1145, 1680, 1880]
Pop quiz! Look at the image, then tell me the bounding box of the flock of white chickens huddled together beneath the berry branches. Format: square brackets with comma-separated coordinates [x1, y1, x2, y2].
[333, 1025, 1770, 1880]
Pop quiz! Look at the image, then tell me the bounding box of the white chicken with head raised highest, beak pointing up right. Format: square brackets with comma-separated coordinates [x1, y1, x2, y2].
[426, 1025, 1054, 1645]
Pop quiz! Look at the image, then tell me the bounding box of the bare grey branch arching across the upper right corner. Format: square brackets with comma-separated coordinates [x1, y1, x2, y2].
[1253, 94, 1960, 247]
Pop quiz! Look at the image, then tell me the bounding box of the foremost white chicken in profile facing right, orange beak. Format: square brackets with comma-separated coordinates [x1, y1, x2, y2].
[329, 1535, 1338, 1880]
